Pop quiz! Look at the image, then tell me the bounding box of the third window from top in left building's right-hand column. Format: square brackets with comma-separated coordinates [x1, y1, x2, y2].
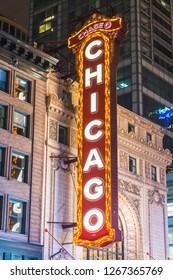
[11, 151, 28, 183]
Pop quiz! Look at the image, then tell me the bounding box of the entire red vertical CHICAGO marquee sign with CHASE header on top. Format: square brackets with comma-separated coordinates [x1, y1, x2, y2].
[68, 14, 126, 247]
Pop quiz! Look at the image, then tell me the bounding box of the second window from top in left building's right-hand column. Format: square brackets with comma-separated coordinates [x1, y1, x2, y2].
[13, 111, 29, 137]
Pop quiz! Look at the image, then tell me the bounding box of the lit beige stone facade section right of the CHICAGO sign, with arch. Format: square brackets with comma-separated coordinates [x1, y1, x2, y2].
[118, 106, 171, 259]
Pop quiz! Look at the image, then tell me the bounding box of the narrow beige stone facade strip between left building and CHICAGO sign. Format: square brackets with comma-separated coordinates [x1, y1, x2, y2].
[44, 74, 78, 259]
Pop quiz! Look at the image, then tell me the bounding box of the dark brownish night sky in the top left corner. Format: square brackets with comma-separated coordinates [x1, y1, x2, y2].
[0, 0, 30, 29]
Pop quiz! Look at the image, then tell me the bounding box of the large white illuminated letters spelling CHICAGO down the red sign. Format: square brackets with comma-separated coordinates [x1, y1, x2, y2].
[83, 38, 105, 233]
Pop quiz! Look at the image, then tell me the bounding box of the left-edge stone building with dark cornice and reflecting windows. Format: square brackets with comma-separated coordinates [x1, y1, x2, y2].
[0, 31, 58, 260]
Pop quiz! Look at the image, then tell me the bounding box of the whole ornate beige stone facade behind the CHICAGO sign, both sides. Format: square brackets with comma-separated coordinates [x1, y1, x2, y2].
[44, 77, 171, 260]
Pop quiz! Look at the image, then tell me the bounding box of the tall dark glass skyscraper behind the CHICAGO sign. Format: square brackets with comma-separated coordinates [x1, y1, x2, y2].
[29, 0, 173, 153]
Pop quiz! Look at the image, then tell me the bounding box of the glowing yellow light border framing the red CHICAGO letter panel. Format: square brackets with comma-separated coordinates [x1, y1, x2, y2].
[74, 31, 115, 247]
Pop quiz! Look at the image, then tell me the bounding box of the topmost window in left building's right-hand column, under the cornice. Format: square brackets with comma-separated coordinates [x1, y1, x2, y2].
[14, 76, 31, 102]
